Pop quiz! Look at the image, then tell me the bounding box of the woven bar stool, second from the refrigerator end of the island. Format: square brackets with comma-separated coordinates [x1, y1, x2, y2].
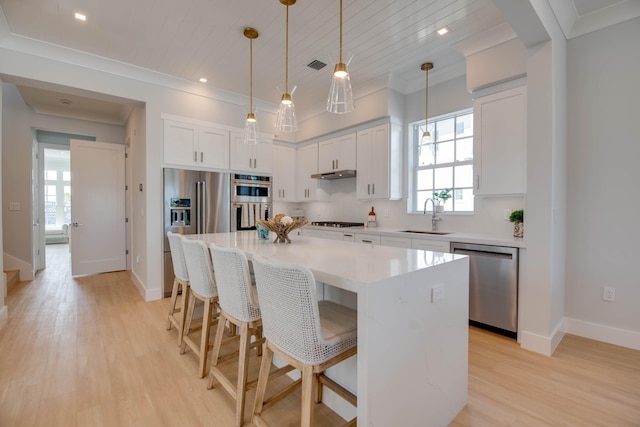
[180, 239, 218, 378]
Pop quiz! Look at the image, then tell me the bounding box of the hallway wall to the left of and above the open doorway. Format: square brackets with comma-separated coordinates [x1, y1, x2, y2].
[2, 83, 124, 270]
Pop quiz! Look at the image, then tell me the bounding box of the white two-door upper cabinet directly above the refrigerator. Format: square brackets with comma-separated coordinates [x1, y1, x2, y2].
[163, 120, 229, 169]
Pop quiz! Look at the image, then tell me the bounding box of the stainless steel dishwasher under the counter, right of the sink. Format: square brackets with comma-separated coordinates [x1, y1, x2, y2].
[451, 242, 518, 338]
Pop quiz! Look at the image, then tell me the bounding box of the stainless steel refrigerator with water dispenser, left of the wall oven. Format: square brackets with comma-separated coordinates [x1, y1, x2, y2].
[163, 168, 231, 296]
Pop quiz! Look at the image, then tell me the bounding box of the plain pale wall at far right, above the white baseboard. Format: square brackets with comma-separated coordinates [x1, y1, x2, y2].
[566, 18, 640, 348]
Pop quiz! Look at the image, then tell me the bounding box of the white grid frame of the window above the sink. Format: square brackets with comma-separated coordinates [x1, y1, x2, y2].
[407, 108, 475, 215]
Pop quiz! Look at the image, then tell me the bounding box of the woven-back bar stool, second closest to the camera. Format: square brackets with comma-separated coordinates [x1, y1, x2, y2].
[207, 244, 264, 427]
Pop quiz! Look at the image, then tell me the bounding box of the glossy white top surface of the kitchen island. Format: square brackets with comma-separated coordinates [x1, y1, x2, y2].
[185, 231, 461, 292]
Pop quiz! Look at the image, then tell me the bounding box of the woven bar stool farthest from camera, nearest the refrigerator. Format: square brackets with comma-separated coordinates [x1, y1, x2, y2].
[167, 231, 189, 347]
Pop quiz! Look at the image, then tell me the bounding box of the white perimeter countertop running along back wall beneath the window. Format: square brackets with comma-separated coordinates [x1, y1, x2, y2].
[305, 225, 526, 248]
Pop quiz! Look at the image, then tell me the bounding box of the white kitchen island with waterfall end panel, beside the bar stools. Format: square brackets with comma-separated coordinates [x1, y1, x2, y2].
[186, 231, 469, 426]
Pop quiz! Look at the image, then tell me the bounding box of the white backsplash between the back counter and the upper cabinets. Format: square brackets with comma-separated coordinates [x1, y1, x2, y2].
[274, 178, 524, 236]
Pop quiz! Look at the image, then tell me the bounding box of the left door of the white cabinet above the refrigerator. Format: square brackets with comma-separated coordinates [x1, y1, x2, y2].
[163, 120, 198, 166]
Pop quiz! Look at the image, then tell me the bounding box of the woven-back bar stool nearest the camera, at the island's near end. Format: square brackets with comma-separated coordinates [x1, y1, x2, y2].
[252, 255, 358, 427]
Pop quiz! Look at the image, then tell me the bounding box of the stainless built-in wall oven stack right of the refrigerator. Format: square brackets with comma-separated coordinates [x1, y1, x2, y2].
[231, 174, 272, 231]
